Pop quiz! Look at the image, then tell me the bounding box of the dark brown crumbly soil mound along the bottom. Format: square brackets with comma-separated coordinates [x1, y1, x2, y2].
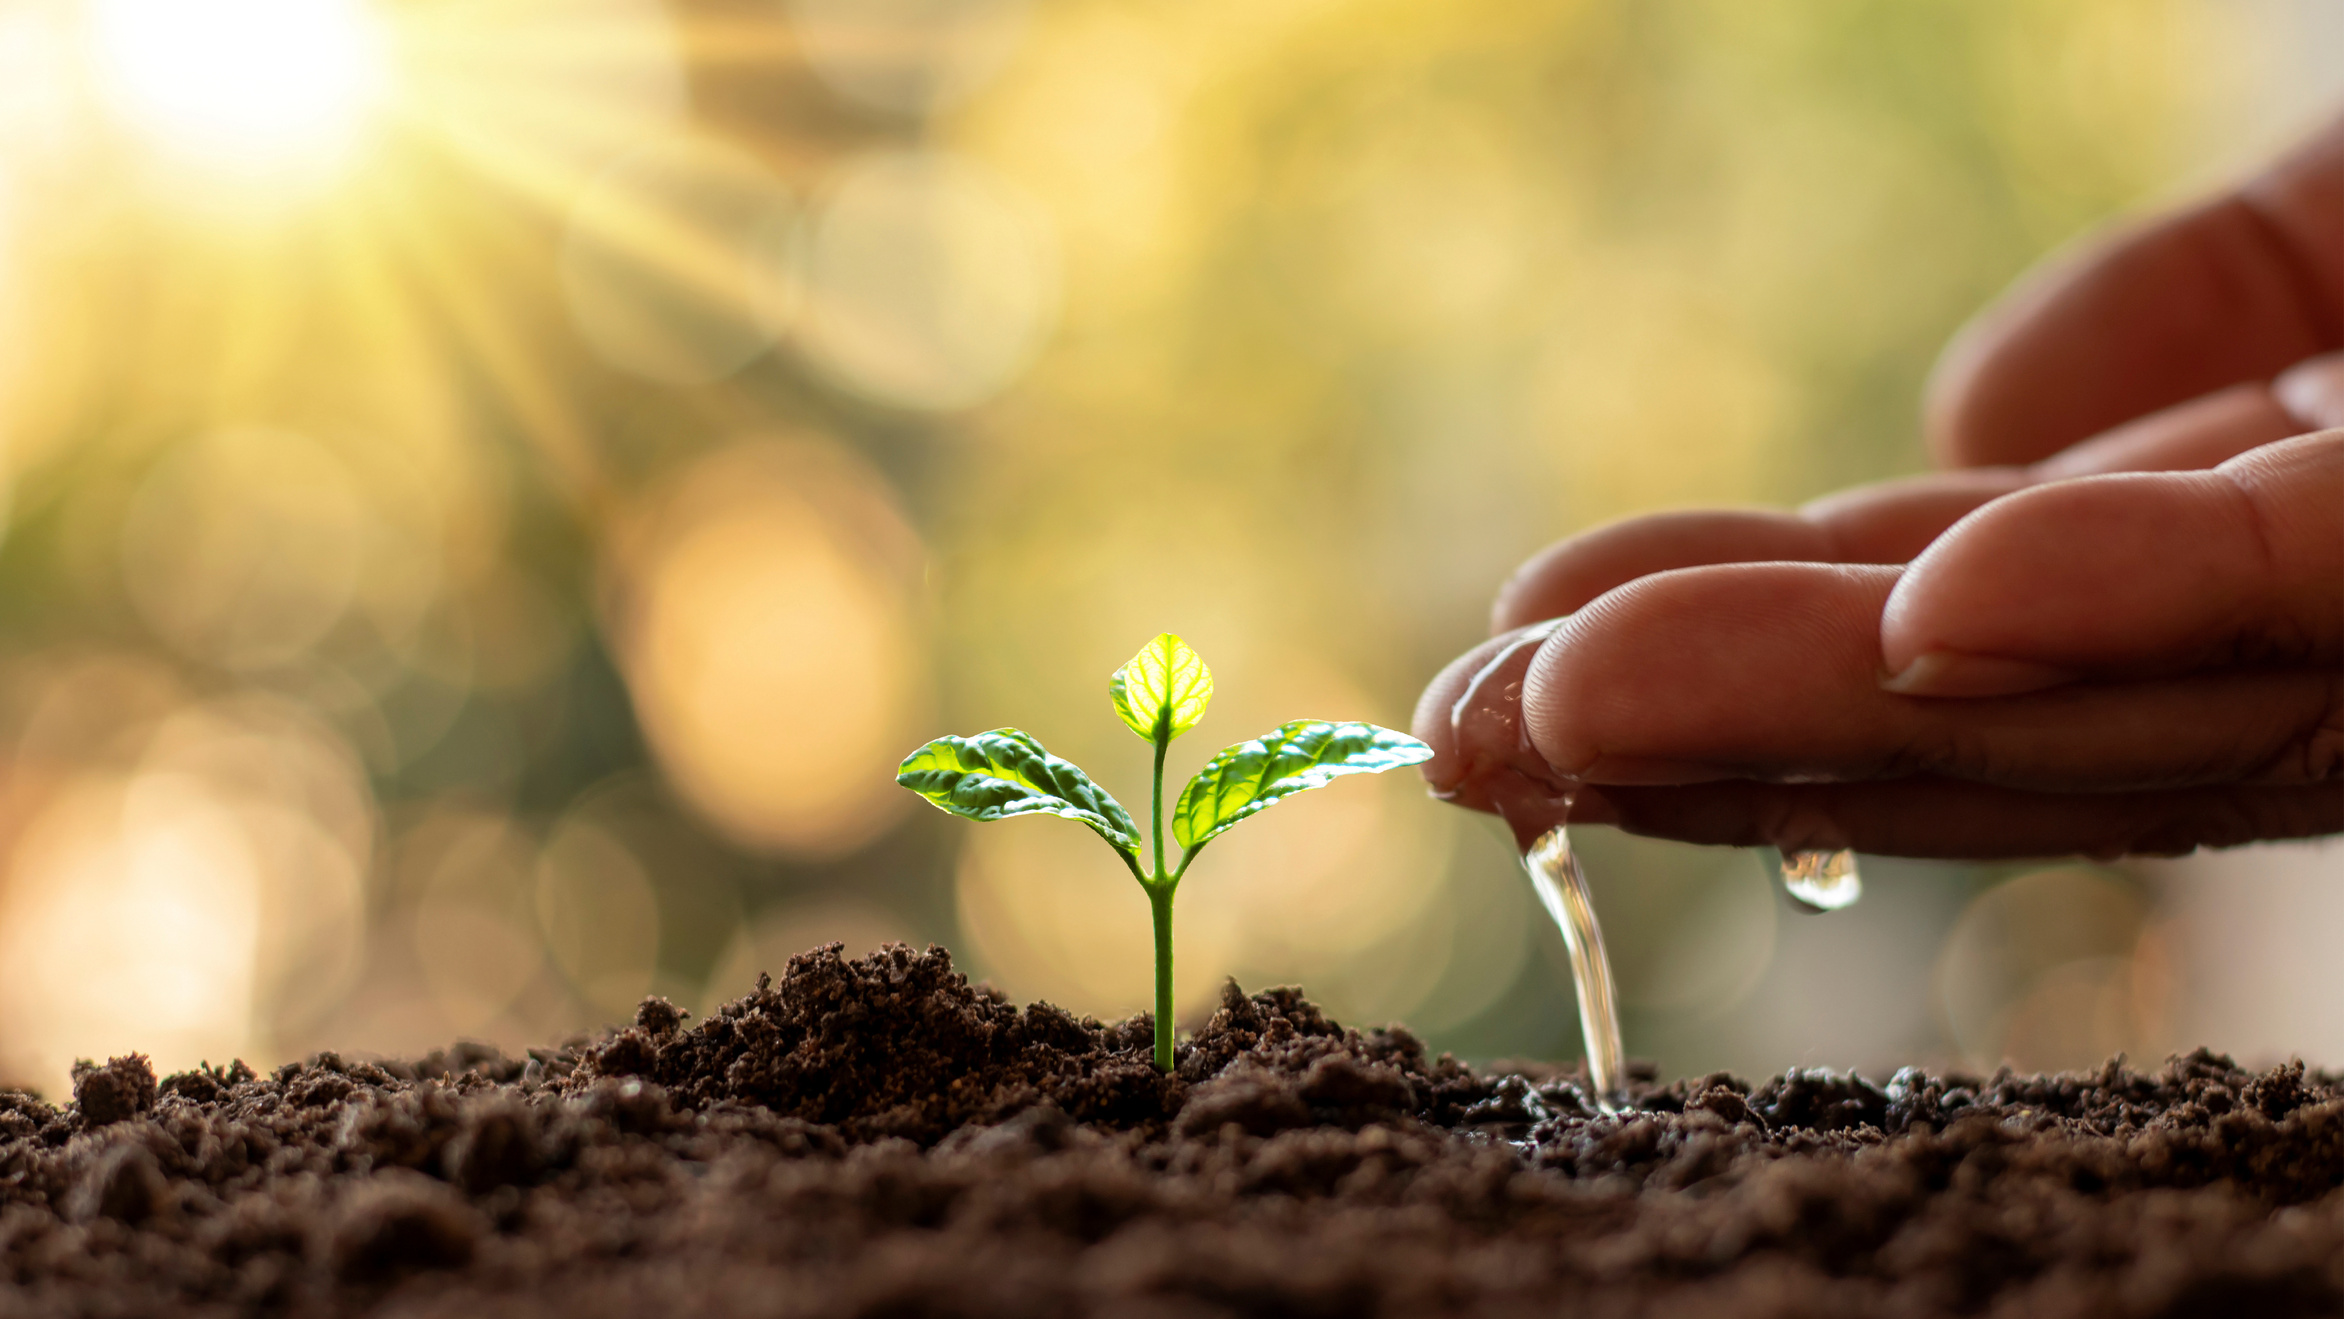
[0, 946, 2344, 1319]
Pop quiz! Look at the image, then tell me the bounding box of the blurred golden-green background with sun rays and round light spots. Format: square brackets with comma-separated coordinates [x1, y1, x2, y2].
[0, 0, 2335, 1092]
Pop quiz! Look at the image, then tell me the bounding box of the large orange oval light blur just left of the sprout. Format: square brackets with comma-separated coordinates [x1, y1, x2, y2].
[614, 443, 928, 857]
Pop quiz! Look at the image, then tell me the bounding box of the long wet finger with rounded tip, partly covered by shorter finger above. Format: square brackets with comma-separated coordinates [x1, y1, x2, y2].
[1521, 562, 2344, 792]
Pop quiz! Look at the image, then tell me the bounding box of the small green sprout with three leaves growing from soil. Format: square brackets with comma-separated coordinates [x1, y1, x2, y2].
[895, 633, 1432, 1071]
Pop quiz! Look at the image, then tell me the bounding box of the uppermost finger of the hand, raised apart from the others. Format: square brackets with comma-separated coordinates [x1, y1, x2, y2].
[1927, 119, 2344, 466]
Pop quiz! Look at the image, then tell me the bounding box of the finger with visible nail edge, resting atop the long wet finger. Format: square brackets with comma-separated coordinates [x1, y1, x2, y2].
[1880, 431, 2344, 696]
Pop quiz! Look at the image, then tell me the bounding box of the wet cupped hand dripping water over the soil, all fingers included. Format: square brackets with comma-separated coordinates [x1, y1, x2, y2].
[1416, 122, 2344, 857]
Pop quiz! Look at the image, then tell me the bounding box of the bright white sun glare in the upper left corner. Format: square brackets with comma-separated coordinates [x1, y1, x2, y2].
[89, 0, 389, 173]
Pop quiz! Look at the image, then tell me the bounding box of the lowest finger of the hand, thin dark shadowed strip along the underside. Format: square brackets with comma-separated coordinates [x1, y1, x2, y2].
[1575, 778, 2344, 860]
